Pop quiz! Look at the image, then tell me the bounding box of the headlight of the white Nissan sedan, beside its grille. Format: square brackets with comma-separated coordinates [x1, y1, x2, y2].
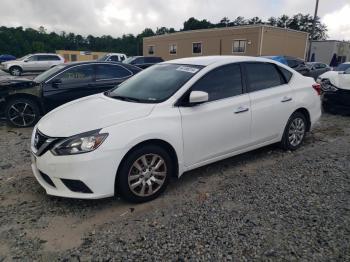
[51, 129, 108, 156]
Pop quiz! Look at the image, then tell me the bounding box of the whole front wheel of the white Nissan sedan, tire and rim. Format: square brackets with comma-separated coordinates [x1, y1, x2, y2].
[116, 145, 174, 203]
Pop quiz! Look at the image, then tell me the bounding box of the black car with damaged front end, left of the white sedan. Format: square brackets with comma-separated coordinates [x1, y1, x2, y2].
[0, 61, 141, 127]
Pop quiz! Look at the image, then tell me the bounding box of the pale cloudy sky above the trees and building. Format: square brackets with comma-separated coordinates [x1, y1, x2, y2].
[0, 0, 350, 40]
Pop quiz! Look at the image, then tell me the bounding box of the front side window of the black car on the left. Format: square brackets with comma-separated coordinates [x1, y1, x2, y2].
[56, 65, 95, 84]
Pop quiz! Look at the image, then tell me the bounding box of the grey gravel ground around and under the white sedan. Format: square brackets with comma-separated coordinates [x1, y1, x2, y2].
[0, 115, 350, 261]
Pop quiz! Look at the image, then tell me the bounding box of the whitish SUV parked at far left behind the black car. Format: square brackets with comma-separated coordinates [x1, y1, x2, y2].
[0, 54, 64, 76]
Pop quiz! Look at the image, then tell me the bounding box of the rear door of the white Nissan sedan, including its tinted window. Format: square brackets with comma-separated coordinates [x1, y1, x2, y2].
[244, 62, 294, 145]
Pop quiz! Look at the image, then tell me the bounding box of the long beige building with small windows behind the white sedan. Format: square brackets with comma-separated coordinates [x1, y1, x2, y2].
[143, 25, 308, 60]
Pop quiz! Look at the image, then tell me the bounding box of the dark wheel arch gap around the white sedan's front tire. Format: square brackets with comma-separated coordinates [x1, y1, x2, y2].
[114, 139, 179, 193]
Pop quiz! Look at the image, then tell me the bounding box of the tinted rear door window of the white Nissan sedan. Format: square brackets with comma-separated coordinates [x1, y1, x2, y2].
[245, 63, 285, 92]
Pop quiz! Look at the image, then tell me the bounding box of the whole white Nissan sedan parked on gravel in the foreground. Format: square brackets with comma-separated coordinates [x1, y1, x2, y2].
[31, 56, 321, 202]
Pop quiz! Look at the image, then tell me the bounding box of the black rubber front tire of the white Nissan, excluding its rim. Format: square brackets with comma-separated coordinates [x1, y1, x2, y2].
[116, 145, 174, 203]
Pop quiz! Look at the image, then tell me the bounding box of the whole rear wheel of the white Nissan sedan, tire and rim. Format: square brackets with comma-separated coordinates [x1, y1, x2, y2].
[281, 112, 307, 151]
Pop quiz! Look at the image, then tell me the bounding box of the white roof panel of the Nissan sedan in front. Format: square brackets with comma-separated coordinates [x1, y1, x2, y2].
[164, 56, 273, 66]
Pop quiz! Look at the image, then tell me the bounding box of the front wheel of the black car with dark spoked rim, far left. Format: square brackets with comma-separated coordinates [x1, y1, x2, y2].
[5, 98, 40, 127]
